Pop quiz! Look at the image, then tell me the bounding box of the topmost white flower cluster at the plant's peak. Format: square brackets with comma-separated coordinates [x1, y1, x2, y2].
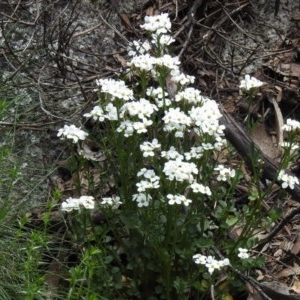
[141, 14, 171, 34]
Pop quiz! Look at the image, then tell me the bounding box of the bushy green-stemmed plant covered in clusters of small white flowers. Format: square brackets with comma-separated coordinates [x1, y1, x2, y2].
[58, 14, 296, 299]
